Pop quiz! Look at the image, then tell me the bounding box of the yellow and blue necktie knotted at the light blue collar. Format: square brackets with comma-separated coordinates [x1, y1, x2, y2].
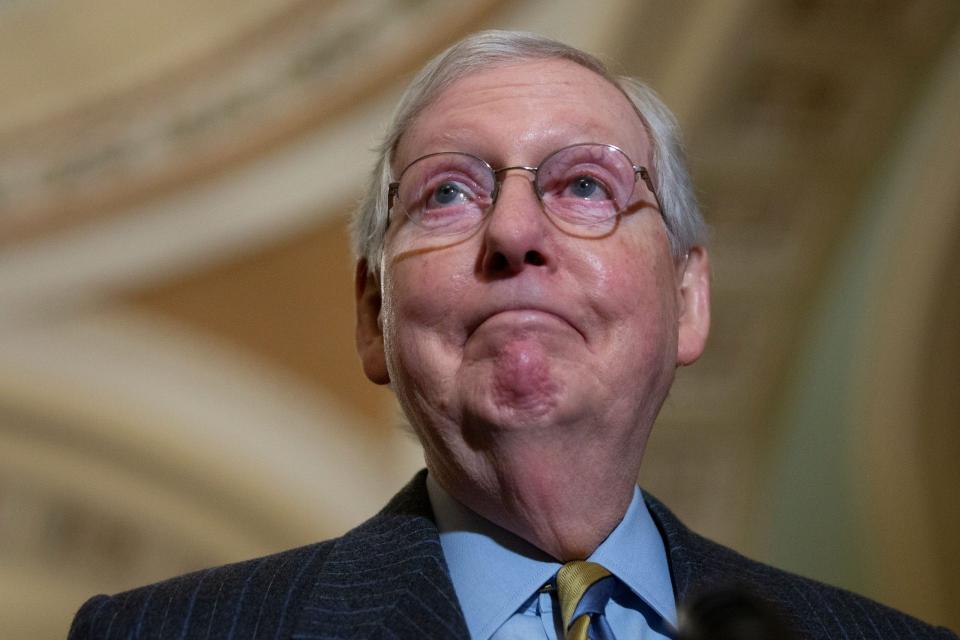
[557, 560, 614, 640]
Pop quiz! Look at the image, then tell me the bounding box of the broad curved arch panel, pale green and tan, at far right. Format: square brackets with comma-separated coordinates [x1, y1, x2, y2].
[769, 21, 960, 624]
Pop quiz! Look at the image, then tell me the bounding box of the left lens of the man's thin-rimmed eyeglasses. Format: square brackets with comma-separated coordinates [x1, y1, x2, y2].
[397, 153, 495, 235]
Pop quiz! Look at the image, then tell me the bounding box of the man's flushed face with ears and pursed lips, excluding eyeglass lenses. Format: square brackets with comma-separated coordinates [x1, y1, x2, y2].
[358, 60, 706, 500]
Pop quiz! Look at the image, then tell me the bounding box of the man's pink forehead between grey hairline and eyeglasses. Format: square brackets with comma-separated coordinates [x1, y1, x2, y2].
[394, 59, 649, 171]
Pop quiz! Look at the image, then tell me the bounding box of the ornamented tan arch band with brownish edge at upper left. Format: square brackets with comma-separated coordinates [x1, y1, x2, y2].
[0, 0, 510, 243]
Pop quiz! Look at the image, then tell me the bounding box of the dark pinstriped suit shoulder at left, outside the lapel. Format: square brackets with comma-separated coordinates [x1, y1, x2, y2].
[69, 540, 337, 640]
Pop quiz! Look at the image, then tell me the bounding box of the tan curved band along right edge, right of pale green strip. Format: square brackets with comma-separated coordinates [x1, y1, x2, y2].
[851, 23, 960, 622]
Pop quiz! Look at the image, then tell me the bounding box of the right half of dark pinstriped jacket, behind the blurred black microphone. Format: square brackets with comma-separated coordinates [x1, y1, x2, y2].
[645, 495, 957, 640]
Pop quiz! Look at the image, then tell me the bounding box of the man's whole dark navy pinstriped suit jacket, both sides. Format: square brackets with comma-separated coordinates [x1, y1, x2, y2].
[70, 472, 957, 640]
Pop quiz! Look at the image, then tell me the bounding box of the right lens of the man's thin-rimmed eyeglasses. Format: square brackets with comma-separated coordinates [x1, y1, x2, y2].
[537, 144, 636, 226]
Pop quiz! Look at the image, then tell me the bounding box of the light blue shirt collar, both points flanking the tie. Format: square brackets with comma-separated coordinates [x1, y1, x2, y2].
[427, 475, 677, 638]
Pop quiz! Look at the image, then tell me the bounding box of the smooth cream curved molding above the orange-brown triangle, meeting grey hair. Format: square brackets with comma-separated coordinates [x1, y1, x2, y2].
[0, 95, 395, 322]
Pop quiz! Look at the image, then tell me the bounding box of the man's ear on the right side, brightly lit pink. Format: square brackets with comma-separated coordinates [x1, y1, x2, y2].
[677, 247, 710, 366]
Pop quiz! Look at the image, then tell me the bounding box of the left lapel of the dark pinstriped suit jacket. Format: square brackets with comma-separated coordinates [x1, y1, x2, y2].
[294, 471, 468, 638]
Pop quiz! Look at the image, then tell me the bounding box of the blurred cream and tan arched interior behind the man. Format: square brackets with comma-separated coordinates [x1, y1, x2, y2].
[0, 0, 960, 639]
